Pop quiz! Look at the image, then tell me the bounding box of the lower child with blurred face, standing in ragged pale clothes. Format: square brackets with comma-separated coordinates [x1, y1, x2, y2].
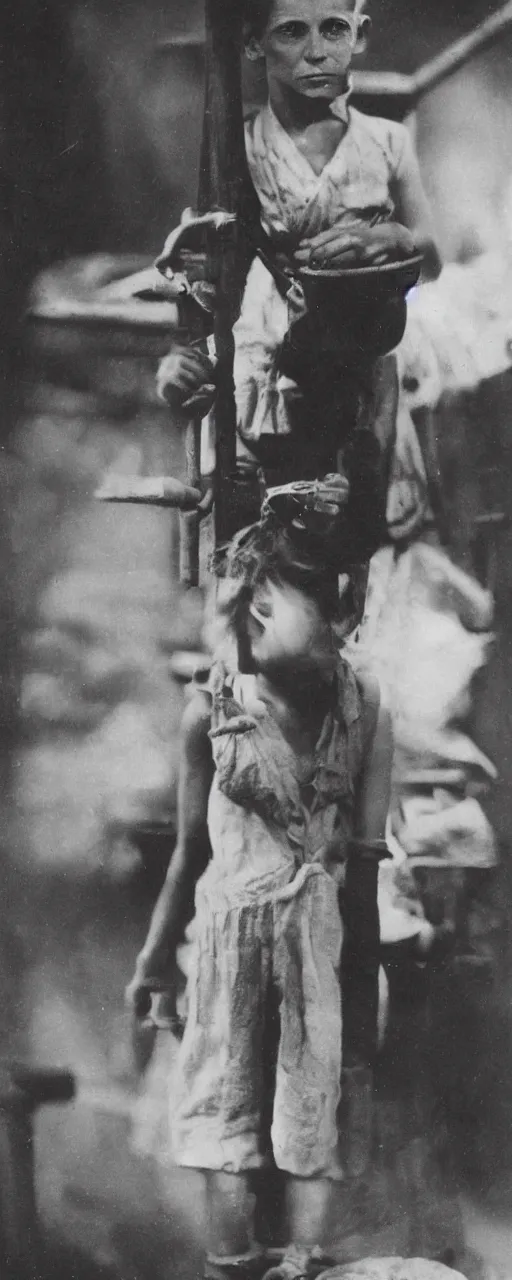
[128, 485, 392, 1280]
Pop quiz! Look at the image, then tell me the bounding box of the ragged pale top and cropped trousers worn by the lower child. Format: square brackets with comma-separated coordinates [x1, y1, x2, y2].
[170, 659, 364, 1178]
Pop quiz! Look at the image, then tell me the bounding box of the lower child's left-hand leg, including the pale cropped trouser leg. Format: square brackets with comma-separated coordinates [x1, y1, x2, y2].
[172, 884, 271, 1280]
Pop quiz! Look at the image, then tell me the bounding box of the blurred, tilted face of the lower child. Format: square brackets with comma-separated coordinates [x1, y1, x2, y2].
[247, 582, 335, 676]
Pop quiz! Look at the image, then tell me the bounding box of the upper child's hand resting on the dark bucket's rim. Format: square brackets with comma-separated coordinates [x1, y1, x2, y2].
[296, 223, 416, 269]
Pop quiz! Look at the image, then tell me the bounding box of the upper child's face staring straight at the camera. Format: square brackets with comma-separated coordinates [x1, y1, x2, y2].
[260, 0, 366, 101]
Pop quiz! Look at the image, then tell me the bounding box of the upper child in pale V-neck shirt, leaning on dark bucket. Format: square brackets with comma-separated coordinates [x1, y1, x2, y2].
[159, 0, 439, 537]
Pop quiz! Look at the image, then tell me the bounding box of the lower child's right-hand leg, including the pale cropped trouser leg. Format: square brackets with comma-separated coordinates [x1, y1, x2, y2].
[269, 874, 342, 1280]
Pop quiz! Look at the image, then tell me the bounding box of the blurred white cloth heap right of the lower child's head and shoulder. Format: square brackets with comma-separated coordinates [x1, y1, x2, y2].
[345, 543, 497, 868]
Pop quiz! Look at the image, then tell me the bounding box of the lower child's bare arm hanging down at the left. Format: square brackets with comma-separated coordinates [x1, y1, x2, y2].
[127, 692, 212, 1016]
